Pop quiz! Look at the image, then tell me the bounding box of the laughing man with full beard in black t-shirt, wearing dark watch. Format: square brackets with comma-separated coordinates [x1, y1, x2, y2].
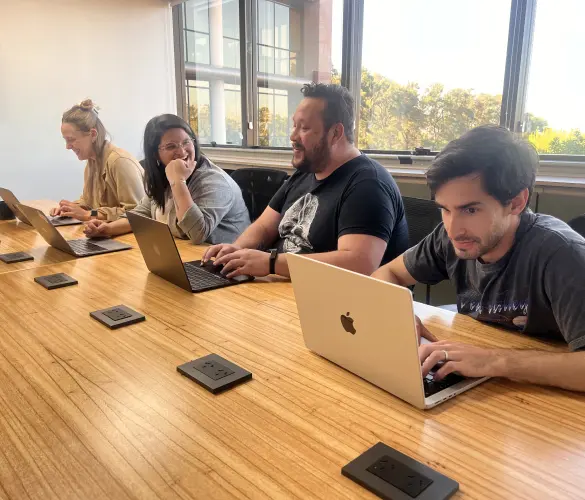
[203, 83, 408, 277]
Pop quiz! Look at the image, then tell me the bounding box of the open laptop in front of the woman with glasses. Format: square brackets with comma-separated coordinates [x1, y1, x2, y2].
[18, 203, 132, 257]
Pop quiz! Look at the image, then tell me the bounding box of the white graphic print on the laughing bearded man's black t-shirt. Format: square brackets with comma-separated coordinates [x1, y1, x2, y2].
[278, 193, 319, 253]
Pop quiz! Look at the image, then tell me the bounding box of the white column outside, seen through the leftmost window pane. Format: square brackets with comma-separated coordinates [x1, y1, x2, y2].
[209, 0, 226, 144]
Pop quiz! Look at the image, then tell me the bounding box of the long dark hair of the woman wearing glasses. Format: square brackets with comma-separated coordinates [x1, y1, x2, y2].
[144, 114, 207, 210]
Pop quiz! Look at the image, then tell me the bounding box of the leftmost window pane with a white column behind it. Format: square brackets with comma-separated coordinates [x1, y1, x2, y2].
[182, 0, 242, 145]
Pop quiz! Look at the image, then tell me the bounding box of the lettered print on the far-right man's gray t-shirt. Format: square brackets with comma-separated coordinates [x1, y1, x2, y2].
[457, 291, 528, 330]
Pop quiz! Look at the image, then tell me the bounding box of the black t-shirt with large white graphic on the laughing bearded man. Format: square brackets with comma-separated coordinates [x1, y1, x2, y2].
[270, 154, 408, 264]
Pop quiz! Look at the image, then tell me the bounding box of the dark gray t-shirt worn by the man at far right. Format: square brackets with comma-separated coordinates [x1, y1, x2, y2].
[404, 211, 585, 351]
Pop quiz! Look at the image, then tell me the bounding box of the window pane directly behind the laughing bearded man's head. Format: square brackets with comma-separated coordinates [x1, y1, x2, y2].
[256, 0, 343, 147]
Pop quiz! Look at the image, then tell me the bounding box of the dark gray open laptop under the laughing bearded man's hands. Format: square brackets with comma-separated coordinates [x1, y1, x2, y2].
[126, 212, 254, 293]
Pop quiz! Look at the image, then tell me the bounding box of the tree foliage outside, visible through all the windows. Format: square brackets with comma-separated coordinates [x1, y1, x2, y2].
[189, 68, 585, 155]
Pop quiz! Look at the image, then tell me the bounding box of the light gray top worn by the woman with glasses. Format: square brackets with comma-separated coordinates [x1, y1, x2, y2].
[127, 159, 250, 245]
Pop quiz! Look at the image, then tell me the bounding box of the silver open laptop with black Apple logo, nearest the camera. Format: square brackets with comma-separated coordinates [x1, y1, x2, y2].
[287, 254, 487, 409]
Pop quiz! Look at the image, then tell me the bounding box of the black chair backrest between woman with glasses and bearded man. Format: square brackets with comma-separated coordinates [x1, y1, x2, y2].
[232, 168, 288, 221]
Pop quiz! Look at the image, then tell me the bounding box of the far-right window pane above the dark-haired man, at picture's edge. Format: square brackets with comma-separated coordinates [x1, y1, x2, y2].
[524, 0, 585, 155]
